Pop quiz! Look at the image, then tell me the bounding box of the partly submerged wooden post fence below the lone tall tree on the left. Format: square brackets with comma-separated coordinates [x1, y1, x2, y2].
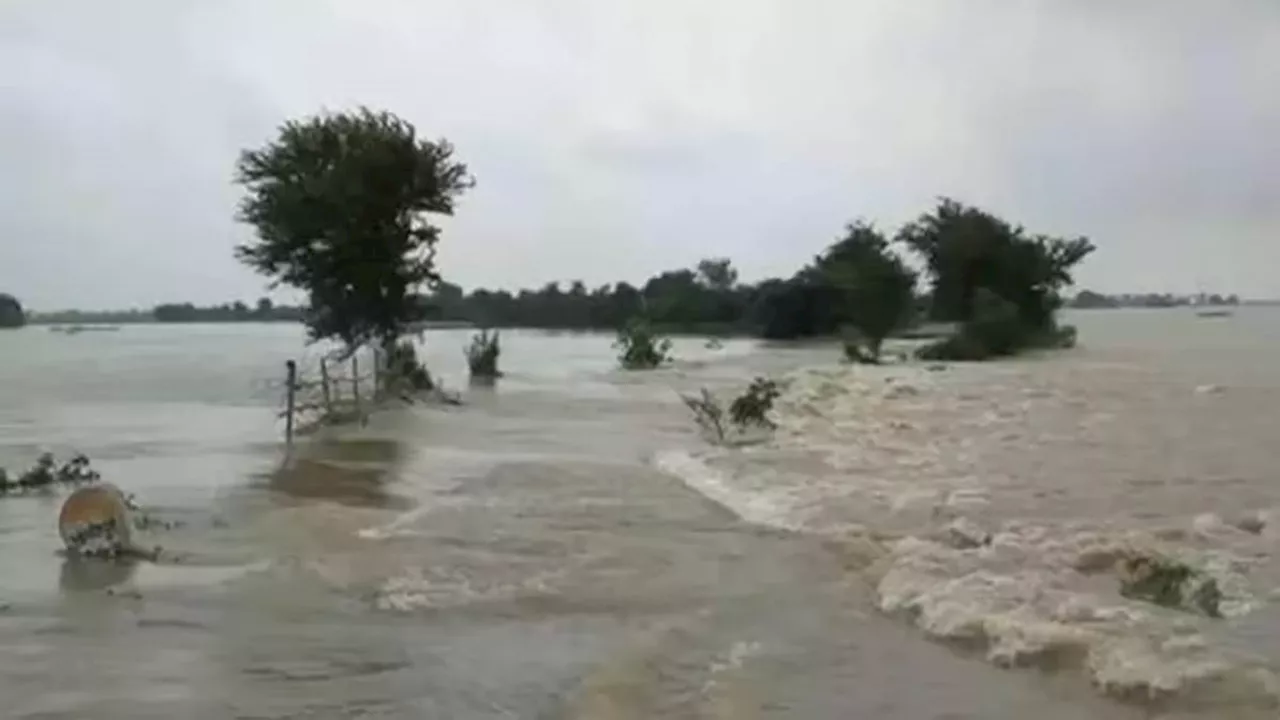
[280, 350, 381, 443]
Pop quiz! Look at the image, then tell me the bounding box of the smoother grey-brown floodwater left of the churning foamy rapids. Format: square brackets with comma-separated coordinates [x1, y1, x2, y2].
[0, 315, 1280, 720]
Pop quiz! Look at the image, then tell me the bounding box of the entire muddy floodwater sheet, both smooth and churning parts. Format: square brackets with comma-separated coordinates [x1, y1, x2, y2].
[0, 309, 1280, 720]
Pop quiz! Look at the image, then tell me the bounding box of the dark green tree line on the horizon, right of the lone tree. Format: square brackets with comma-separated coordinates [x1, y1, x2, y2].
[421, 199, 1093, 354]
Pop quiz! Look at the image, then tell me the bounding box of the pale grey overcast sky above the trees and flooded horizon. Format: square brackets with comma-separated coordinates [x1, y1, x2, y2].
[0, 0, 1280, 309]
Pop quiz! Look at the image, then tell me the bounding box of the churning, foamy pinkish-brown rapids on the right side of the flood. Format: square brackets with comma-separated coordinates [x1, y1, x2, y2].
[657, 364, 1280, 705]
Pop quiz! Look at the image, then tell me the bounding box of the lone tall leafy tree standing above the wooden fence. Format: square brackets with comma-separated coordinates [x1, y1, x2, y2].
[236, 108, 474, 351]
